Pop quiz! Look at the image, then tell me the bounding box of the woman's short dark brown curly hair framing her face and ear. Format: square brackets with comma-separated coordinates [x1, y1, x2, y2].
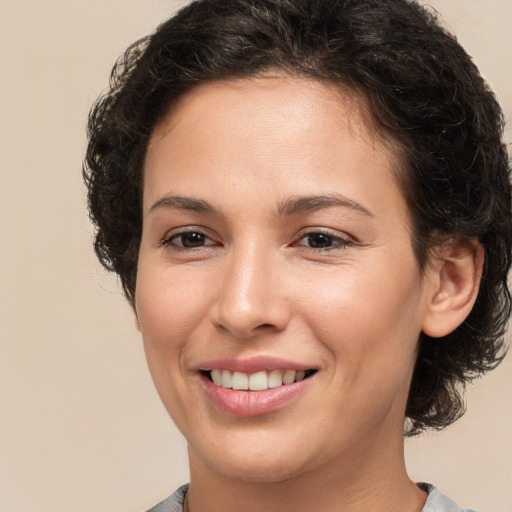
[84, 0, 511, 435]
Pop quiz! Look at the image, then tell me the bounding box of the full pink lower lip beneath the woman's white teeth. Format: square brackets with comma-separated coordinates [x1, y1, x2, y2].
[201, 375, 312, 416]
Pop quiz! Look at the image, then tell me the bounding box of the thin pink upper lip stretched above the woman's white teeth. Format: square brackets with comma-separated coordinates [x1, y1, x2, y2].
[198, 356, 316, 374]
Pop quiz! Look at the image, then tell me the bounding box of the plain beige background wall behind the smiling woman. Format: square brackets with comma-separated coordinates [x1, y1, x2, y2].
[0, 0, 512, 512]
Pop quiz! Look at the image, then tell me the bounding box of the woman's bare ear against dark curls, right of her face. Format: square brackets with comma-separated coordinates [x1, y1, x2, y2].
[423, 238, 484, 338]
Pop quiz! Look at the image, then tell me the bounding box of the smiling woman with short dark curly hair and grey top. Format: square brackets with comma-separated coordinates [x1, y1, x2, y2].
[85, 0, 511, 512]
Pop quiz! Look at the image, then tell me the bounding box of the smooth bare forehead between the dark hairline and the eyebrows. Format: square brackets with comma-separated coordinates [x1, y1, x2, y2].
[144, 75, 408, 223]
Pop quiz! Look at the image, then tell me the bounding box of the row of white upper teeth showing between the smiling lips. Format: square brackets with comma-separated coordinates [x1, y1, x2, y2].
[201, 369, 317, 391]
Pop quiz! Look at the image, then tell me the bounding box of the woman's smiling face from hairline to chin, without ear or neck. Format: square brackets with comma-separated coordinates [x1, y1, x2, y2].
[136, 77, 432, 481]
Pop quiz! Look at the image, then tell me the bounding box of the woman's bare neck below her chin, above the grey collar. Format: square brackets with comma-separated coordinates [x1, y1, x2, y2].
[188, 437, 426, 512]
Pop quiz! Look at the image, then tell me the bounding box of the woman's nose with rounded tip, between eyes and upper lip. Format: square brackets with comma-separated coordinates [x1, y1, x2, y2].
[212, 241, 291, 339]
